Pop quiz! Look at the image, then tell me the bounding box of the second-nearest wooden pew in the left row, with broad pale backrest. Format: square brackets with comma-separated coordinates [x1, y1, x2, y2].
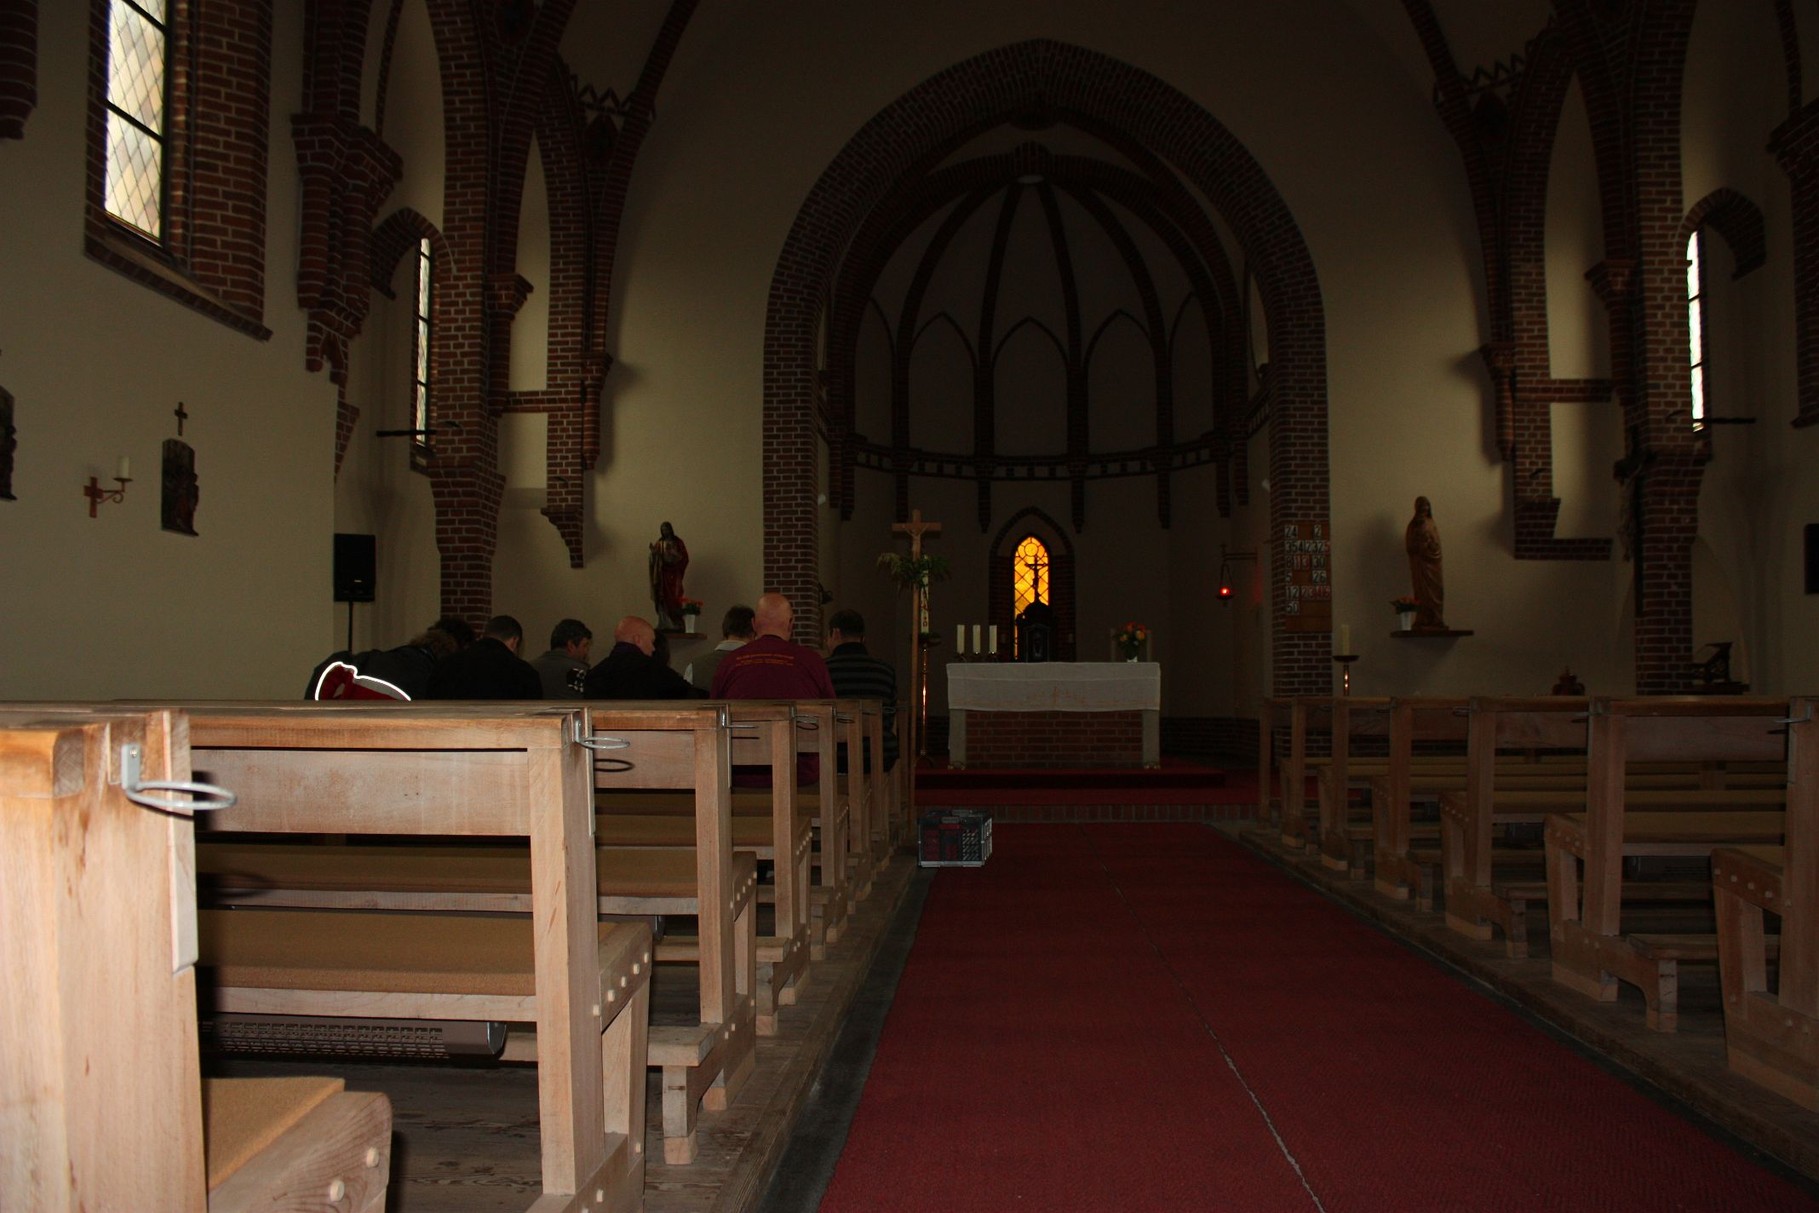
[191, 704, 665, 1209]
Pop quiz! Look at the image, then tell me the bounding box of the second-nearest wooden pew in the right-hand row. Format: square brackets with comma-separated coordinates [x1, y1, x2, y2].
[1546, 695, 1788, 1031]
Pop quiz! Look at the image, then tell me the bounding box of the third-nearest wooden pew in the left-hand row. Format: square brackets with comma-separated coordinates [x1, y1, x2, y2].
[204, 702, 757, 1164]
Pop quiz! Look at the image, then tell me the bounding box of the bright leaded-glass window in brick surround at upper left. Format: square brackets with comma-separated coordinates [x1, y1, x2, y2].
[106, 0, 166, 240]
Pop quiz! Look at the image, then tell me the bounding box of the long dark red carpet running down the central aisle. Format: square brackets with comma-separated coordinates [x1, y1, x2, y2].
[822, 824, 1819, 1213]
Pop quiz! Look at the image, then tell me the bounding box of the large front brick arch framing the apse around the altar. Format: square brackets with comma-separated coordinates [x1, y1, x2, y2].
[764, 38, 1332, 695]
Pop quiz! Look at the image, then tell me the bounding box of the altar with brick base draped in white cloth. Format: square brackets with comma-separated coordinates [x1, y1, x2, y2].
[948, 662, 1162, 769]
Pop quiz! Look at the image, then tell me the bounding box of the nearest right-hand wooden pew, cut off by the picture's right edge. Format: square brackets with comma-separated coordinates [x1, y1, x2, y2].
[1712, 698, 1819, 1111]
